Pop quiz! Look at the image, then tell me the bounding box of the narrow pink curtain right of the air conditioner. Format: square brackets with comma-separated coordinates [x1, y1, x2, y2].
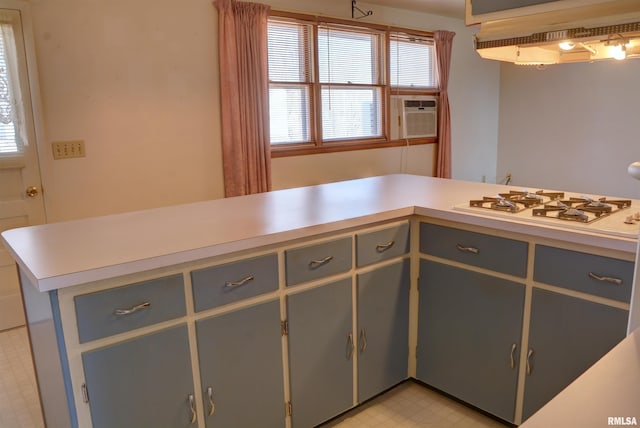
[433, 31, 456, 178]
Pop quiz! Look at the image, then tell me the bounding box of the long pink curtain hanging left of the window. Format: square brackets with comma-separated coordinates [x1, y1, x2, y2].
[214, 0, 271, 197]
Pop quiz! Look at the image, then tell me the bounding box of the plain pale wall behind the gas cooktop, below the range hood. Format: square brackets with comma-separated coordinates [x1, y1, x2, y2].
[498, 59, 640, 198]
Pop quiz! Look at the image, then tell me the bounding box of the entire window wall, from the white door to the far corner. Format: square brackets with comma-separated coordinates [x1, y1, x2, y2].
[32, 0, 499, 221]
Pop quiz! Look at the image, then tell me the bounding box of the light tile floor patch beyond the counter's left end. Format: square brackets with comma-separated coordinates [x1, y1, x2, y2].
[0, 327, 44, 428]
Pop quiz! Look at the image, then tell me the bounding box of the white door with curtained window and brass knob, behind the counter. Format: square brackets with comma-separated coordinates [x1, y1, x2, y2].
[0, 9, 45, 331]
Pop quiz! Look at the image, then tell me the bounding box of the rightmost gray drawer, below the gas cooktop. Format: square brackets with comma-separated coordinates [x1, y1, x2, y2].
[533, 245, 633, 303]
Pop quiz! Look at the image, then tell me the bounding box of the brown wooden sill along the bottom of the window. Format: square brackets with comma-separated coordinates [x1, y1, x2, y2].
[271, 137, 438, 158]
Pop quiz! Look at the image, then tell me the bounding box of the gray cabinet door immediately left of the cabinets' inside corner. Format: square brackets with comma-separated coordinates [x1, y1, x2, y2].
[357, 260, 411, 402]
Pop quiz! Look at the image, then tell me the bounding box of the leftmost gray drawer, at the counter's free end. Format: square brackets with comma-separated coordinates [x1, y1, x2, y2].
[74, 275, 186, 343]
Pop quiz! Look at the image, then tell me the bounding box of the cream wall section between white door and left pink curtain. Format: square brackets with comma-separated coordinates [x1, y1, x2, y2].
[32, 0, 223, 221]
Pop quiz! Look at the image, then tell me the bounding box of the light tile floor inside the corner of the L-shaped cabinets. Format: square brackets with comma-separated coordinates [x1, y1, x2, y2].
[322, 382, 507, 428]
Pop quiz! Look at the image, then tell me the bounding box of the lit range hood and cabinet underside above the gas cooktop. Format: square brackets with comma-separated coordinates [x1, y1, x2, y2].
[466, 0, 640, 65]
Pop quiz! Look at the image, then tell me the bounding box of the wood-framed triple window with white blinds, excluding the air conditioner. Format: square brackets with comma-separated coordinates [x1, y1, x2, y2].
[268, 12, 438, 157]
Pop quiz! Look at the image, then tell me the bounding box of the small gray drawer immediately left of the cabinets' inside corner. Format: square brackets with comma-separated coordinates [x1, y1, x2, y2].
[356, 223, 409, 266]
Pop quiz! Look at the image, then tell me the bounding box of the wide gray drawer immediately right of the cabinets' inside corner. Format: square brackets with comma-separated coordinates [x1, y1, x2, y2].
[420, 223, 528, 278]
